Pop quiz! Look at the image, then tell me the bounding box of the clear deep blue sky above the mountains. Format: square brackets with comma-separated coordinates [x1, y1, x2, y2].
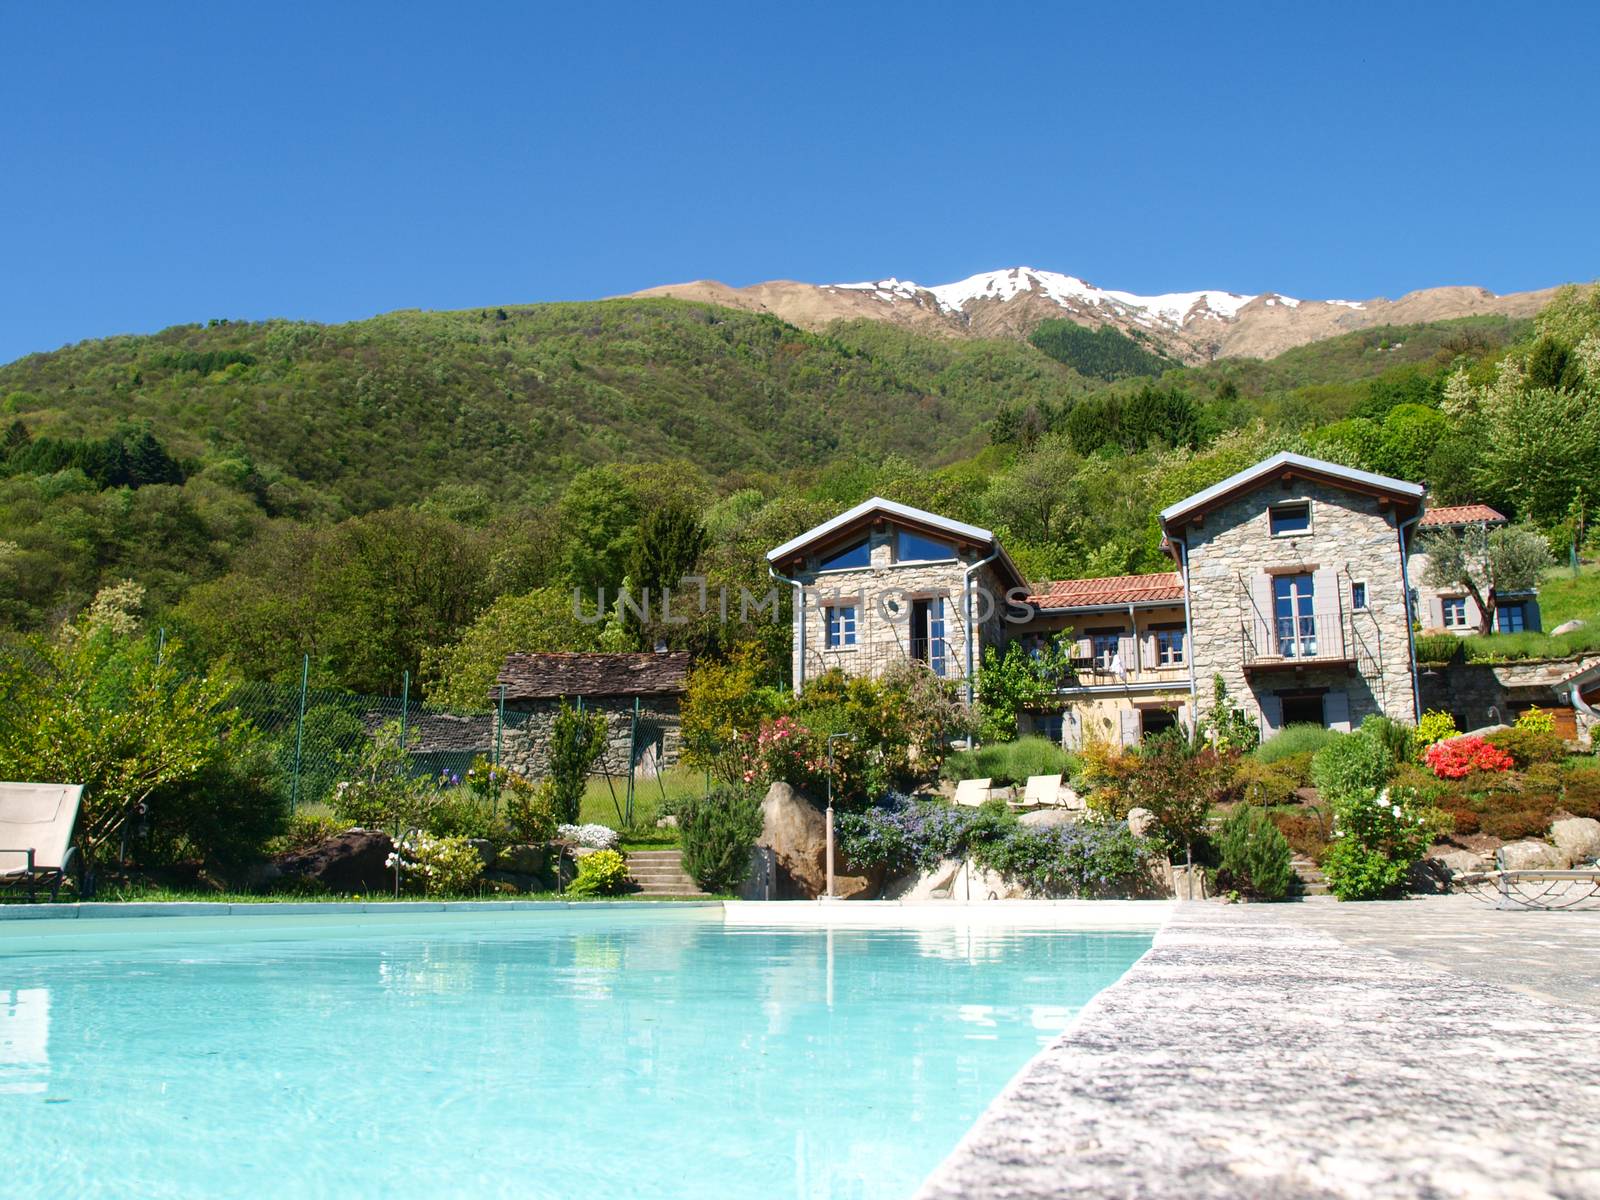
[0, 0, 1600, 362]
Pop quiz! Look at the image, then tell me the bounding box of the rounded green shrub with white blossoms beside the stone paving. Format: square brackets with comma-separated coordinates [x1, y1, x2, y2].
[1322, 790, 1450, 901]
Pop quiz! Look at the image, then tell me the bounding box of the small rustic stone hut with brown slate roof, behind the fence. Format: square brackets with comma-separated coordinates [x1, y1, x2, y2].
[490, 651, 690, 779]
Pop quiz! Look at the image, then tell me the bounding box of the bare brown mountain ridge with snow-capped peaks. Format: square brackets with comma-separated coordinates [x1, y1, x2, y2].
[630, 267, 1557, 365]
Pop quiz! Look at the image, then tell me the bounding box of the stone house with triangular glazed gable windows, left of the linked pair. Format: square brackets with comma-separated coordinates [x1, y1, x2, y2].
[766, 496, 1027, 699]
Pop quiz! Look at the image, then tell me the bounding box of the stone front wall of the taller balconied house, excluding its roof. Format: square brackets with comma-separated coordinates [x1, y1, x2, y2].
[1171, 477, 1416, 736]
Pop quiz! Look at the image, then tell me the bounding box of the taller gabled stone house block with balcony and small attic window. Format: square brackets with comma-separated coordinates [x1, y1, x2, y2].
[1160, 453, 1424, 738]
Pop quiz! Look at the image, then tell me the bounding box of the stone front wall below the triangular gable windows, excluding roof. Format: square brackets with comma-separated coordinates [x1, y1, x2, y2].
[792, 523, 1006, 685]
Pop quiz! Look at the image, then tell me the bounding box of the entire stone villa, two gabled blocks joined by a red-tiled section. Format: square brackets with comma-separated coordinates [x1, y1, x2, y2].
[768, 454, 1424, 746]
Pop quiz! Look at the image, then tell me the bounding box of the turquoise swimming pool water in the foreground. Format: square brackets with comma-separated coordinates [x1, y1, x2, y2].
[0, 907, 1150, 1200]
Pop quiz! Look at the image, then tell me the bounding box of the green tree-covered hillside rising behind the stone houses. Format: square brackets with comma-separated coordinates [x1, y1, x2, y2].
[0, 290, 1600, 699]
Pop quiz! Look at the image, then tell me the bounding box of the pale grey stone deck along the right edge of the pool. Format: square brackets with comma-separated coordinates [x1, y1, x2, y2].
[920, 896, 1600, 1200]
